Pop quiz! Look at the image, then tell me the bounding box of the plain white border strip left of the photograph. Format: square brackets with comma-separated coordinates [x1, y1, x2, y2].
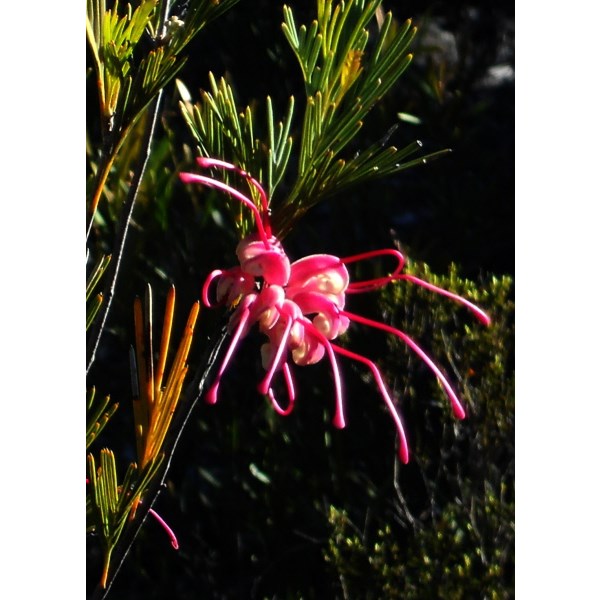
[0, 2, 85, 600]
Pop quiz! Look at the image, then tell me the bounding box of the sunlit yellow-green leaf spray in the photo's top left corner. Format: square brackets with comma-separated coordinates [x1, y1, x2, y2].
[86, 0, 238, 234]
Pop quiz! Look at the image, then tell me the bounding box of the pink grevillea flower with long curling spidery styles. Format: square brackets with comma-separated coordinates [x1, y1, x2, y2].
[180, 158, 490, 463]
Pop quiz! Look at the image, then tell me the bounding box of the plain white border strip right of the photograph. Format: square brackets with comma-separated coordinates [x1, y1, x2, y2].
[516, 2, 600, 599]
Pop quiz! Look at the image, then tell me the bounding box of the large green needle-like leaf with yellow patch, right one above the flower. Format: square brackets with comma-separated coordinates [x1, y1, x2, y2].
[273, 0, 419, 236]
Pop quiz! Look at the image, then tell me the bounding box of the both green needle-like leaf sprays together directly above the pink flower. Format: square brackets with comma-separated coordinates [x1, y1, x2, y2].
[180, 0, 438, 238]
